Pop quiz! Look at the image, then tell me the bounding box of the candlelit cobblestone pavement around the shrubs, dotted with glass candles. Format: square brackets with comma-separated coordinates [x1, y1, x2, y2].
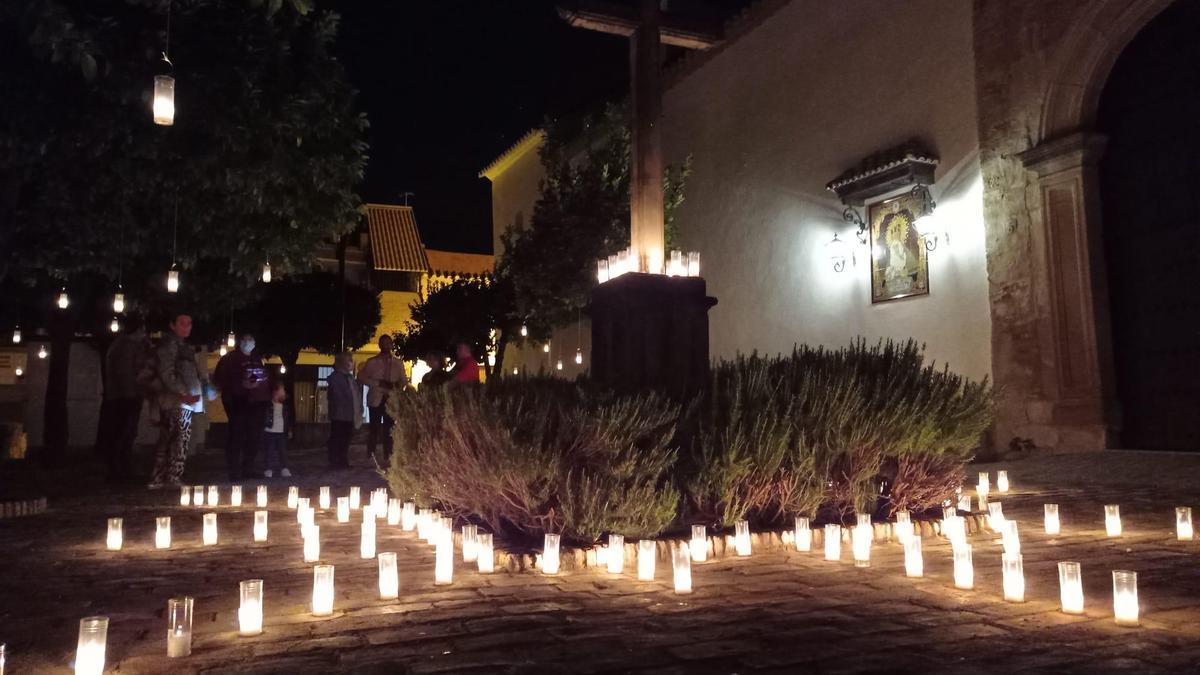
[0, 453, 1200, 673]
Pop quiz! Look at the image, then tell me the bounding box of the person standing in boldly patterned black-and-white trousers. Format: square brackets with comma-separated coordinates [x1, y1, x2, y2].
[145, 311, 212, 489]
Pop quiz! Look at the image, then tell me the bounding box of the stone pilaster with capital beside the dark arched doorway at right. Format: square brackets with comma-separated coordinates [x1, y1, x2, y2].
[1020, 132, 1120, 449]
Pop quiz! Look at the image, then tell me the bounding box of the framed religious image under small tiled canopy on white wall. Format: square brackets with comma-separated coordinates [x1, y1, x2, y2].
[870, 192, 929, 304]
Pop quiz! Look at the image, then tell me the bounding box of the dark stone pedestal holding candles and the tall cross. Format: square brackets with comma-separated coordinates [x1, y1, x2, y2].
[588, 274, 716, 396]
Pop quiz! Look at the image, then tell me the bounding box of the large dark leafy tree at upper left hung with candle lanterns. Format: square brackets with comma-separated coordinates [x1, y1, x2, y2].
[0, 0, 366, 454]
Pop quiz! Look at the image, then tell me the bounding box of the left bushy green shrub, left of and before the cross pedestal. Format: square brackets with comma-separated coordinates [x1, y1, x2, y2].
[388, 378, 679, 543]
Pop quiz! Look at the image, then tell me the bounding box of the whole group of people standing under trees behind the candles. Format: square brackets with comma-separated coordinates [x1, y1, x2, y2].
[96, 312, 479, 489]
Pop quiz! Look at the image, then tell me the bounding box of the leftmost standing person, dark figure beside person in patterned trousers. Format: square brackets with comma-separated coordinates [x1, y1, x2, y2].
[97, 316, 151, 483]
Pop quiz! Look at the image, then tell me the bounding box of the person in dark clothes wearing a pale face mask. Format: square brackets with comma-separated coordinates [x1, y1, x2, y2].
[212, 333, 271, 482]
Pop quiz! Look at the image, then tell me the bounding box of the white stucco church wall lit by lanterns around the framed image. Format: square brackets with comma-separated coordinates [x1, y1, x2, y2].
[662, 0, 991, 377]
